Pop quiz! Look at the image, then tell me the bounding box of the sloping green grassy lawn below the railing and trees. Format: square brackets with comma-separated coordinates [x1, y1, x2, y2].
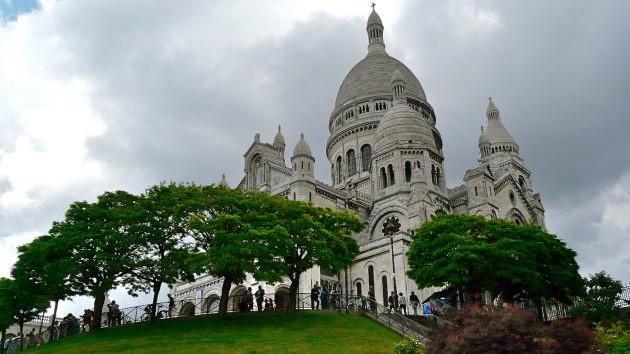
[29, 312, 402, 354]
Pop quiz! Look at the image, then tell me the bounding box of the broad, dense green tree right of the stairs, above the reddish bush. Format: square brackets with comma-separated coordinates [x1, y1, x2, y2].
[407, 214, 582, 303]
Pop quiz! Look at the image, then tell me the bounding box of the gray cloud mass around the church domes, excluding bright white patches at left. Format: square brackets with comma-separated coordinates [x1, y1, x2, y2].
[0, 1, 630, 280]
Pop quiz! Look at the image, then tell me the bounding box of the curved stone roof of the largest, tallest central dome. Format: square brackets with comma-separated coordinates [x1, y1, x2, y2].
[335, 52, 426, 110]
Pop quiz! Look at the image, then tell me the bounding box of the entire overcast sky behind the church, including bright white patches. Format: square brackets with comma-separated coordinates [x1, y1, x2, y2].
[0, 0, 630, 316]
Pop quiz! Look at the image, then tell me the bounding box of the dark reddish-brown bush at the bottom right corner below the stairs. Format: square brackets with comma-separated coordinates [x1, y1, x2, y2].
[427, 307, 595, 354]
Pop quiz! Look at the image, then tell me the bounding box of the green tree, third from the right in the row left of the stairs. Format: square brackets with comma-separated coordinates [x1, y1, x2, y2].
[124, 183, 201, 320]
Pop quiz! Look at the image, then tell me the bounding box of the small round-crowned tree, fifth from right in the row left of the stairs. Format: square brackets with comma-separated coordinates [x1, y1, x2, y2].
[12, 235, 75, 339]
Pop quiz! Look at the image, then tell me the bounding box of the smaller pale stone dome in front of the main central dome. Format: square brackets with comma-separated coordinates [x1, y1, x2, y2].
[374, 104, 437, 153]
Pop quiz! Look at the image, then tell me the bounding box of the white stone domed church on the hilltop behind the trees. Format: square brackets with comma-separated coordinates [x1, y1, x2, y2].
[171, 6, 544, 312]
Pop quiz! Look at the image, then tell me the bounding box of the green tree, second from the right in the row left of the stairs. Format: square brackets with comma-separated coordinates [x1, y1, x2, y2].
[189, 186, 278, 317]
